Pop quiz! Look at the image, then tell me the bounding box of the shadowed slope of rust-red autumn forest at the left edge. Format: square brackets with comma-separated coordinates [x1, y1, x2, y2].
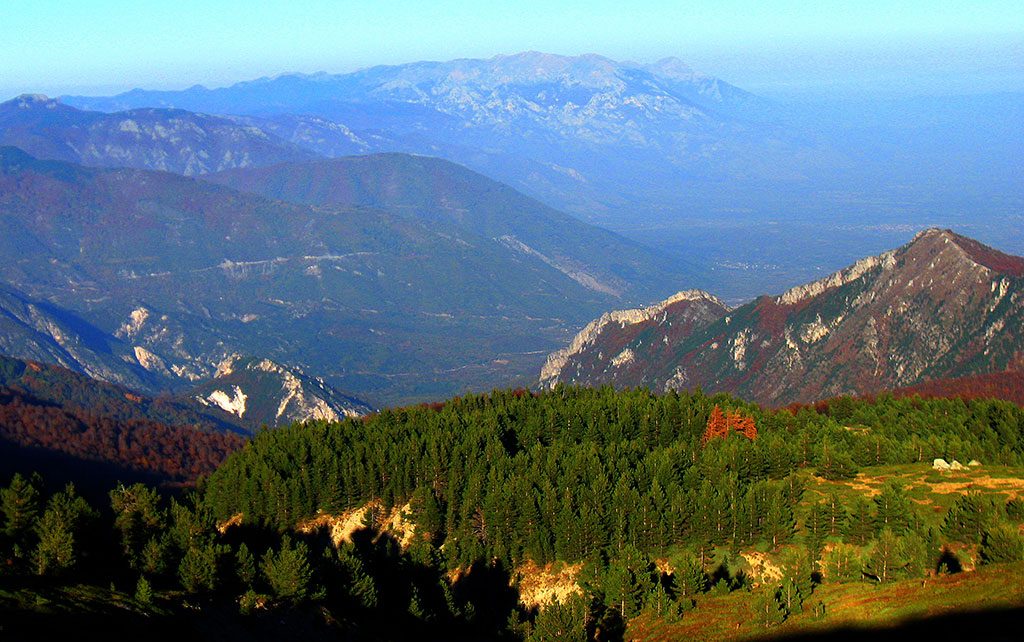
[0, 355, 245, 485]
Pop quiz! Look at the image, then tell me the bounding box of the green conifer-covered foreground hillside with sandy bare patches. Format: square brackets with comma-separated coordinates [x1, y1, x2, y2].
[0, 386, 1024, 640]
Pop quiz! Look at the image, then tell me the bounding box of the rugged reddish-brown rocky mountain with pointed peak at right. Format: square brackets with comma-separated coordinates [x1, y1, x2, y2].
[542, 229, 1024, 404]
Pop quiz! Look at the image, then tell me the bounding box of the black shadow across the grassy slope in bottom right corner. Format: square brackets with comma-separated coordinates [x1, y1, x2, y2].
[757, 608, 1024, 642]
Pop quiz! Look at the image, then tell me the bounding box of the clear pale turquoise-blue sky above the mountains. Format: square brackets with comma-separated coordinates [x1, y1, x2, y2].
[0, 0, 1024, 97]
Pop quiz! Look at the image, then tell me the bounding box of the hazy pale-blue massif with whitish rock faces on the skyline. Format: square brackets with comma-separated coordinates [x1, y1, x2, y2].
[61, 51, 815, 220]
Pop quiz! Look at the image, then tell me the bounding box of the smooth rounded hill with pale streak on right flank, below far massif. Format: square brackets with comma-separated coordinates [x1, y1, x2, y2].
[207, 154, 678, 300]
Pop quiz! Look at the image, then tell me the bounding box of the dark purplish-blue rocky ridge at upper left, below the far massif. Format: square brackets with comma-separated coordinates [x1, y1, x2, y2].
[0, 95, 315, 175]
